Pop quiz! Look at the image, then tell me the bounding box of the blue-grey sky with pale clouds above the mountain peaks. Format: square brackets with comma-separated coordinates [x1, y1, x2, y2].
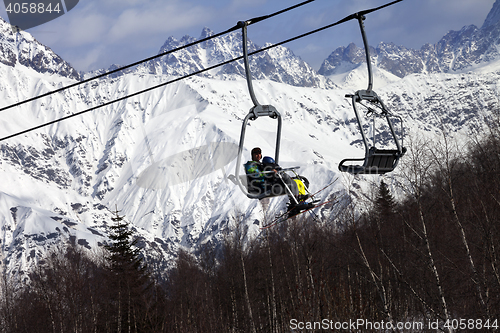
[0, 0, 494, 71]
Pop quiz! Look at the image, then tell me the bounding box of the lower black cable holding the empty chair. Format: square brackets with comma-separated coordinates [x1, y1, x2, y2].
[0, 0, 403, 142]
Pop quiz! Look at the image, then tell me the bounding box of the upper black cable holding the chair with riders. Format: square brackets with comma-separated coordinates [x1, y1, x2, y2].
[0, 0, 316, 112]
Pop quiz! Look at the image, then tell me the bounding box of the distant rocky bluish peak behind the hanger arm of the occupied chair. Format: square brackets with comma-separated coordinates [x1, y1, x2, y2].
[94, 28, 335, 89]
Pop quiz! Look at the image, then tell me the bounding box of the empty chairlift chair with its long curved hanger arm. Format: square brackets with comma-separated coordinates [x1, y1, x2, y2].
[339, 13, 406, 175]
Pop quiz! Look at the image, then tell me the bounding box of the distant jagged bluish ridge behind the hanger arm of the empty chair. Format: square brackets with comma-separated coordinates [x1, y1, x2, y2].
[318, 1, 500, 78]
